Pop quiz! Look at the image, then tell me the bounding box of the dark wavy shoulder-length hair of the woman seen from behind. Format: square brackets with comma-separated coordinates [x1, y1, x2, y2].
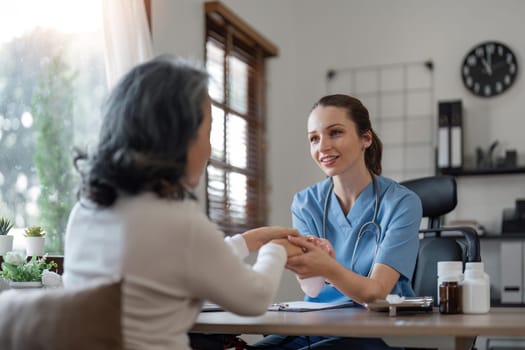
[74, 56, 208, 206]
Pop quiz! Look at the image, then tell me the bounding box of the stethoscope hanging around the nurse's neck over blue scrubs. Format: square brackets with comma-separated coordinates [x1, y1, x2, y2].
[321, 175, 381, 276]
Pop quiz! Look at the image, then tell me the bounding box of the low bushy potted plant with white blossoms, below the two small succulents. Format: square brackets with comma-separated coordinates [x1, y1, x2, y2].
[0, 252, 61, 288]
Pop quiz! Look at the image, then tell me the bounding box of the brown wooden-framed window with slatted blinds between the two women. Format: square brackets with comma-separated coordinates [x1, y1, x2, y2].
[205, 2, 277, 234]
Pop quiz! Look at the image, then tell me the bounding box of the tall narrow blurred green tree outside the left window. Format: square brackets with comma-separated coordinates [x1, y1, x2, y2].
[31, 56, 75, 253]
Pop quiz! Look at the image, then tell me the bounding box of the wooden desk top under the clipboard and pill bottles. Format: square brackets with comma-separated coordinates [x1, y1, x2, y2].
[192, 308, 525, 349]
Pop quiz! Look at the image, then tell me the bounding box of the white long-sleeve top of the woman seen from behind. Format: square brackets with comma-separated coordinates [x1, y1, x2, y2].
[63, 193, 286, 350]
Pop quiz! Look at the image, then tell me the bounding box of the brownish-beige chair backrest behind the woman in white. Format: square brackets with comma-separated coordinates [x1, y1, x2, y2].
[0, 280, 124, 350]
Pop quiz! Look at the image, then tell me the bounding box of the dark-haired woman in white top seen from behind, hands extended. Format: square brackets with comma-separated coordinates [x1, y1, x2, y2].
[64, 56, 301, 350]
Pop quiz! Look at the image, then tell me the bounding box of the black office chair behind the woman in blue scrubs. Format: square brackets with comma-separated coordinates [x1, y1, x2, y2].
[401, 175, 481, 304]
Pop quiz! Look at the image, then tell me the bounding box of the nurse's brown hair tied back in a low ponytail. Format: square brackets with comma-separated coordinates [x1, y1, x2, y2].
[312, 94, 383, 175]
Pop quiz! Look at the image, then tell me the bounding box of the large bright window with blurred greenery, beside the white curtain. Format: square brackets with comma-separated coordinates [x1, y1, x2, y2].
[0, 0, 107, 253]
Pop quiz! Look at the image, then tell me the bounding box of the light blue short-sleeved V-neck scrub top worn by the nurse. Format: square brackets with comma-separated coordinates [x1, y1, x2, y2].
[292, 176, 422, 302]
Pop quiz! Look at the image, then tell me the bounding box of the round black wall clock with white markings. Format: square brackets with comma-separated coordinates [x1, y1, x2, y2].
[461, 41, 518, 97]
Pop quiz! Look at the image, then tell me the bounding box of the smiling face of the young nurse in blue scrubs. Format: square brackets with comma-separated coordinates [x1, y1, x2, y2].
[308, 106, 372, 176]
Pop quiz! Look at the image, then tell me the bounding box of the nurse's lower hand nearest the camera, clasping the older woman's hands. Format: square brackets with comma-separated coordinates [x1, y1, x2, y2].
[286, 237, 339, 279]
